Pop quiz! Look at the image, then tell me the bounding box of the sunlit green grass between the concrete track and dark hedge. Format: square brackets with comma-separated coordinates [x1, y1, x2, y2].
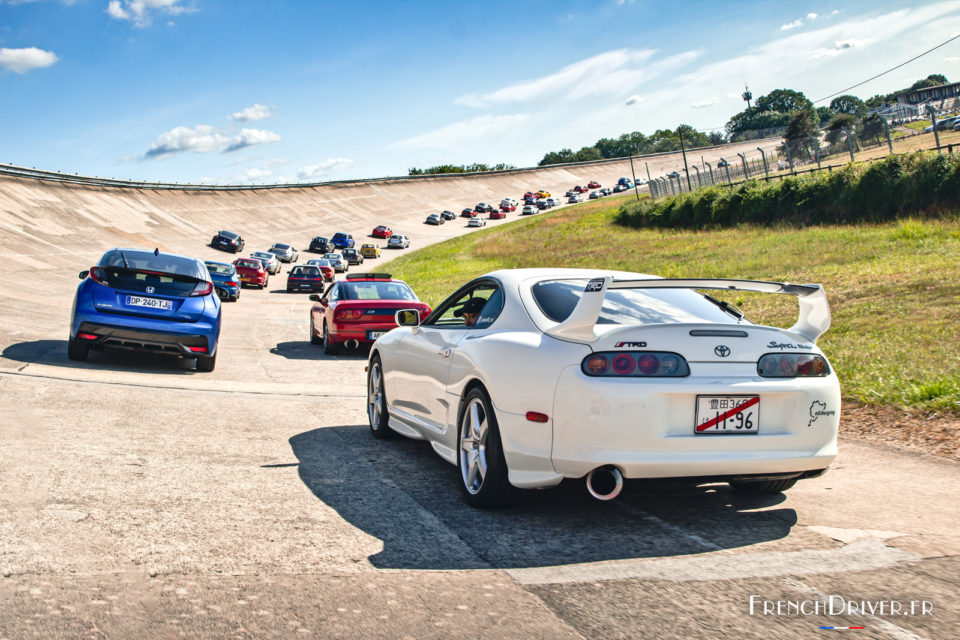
[386, 196, 960, 415]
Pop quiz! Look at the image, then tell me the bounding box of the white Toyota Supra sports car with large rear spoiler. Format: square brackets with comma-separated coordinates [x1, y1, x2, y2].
[367, 269, 840, 506]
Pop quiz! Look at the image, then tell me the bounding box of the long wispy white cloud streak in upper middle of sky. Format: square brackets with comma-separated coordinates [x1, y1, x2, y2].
[454, 49, 660, 107]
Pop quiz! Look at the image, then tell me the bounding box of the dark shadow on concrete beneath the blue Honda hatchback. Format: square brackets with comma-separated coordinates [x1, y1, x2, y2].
[0, 340, 202, 374]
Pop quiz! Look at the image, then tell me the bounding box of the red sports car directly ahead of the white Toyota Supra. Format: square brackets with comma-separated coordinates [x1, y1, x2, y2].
[310, 273, 431, 354]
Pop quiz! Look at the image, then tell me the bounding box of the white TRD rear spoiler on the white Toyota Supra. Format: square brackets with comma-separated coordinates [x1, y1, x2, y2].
[546, 276, 830, 342]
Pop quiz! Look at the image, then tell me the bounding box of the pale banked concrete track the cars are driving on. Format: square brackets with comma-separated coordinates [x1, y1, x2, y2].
[0, 156, 960, 639]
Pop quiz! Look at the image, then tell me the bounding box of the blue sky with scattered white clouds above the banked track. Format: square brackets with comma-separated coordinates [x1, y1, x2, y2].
[0, 0, 960, 184]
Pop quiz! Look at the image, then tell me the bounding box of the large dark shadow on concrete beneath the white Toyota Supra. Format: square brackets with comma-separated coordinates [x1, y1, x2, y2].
[290, 426, 797, 570]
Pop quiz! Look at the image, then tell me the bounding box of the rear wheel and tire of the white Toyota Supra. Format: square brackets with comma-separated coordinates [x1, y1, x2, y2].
[457, 387, 518, 508]
